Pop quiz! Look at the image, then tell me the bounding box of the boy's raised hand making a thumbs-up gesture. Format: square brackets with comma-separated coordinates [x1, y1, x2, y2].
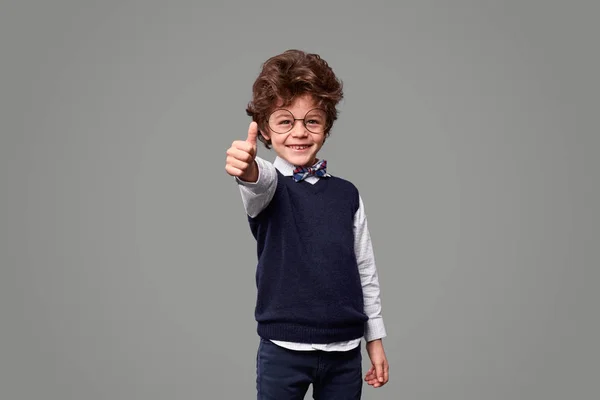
[225, 121, 258, 182]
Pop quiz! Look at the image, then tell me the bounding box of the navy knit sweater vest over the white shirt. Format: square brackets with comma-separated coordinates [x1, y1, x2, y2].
[248, 171, 368, 343]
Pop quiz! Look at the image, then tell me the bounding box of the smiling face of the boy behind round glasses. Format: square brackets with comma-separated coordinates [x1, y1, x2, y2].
[261, 95, 326, 166]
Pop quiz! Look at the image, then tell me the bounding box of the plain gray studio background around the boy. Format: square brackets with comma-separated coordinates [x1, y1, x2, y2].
[0, 0, 600, 400]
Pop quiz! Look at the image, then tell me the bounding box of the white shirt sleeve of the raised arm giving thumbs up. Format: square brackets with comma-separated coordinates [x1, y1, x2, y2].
[235, 157, 277, 218]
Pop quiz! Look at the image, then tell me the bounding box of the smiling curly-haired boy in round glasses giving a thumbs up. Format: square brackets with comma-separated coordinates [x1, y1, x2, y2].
[225, 50, 388, 400]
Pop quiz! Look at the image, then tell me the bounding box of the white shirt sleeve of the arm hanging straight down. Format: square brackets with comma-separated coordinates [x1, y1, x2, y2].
[354, 197, 387, 342]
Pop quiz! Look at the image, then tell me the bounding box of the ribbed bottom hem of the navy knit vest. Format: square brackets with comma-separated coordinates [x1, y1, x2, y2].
[257, 322, 365, 344]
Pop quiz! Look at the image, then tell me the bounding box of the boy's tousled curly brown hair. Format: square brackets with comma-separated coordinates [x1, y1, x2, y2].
[246, 49, 344, 149]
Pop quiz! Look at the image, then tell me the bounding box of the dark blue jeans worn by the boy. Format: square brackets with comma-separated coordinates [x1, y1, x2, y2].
[256, 339, 362, 400]
